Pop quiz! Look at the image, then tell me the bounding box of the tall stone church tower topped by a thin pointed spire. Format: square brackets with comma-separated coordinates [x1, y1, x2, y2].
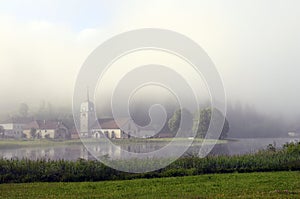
[80, 89, 95, 137]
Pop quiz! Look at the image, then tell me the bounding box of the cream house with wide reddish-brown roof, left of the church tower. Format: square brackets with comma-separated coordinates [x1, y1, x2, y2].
[23, 120, 71, 139]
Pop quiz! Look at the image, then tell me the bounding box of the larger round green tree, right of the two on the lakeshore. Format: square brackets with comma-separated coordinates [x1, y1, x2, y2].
[195, 108, 229, 139]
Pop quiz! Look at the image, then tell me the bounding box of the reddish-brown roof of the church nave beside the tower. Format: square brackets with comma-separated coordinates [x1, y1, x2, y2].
[92, 118, 129, 129]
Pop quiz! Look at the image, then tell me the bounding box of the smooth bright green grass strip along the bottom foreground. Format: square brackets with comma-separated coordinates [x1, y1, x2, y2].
[0, 171, 300, 198]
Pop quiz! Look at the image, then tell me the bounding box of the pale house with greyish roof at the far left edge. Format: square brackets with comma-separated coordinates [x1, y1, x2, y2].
[0, 118, 32, 139]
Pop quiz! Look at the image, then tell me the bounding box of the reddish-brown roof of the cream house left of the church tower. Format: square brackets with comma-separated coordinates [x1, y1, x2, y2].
[24, 120, 66, 130]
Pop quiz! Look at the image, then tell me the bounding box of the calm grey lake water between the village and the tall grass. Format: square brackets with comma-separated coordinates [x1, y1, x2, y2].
[0, 138, 300, 160]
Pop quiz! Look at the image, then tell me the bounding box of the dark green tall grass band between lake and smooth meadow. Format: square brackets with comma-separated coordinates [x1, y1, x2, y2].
[0, 142, 300, 183]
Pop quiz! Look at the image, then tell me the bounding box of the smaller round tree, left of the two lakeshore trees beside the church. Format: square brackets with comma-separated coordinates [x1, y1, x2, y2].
[168, 108, 193, 133]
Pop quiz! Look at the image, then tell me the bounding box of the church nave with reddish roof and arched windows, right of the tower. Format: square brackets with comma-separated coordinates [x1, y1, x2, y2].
[91, 118, 132, 139]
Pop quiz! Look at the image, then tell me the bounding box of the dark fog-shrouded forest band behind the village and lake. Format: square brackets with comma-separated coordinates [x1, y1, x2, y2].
[1, 98, 292, 138]
